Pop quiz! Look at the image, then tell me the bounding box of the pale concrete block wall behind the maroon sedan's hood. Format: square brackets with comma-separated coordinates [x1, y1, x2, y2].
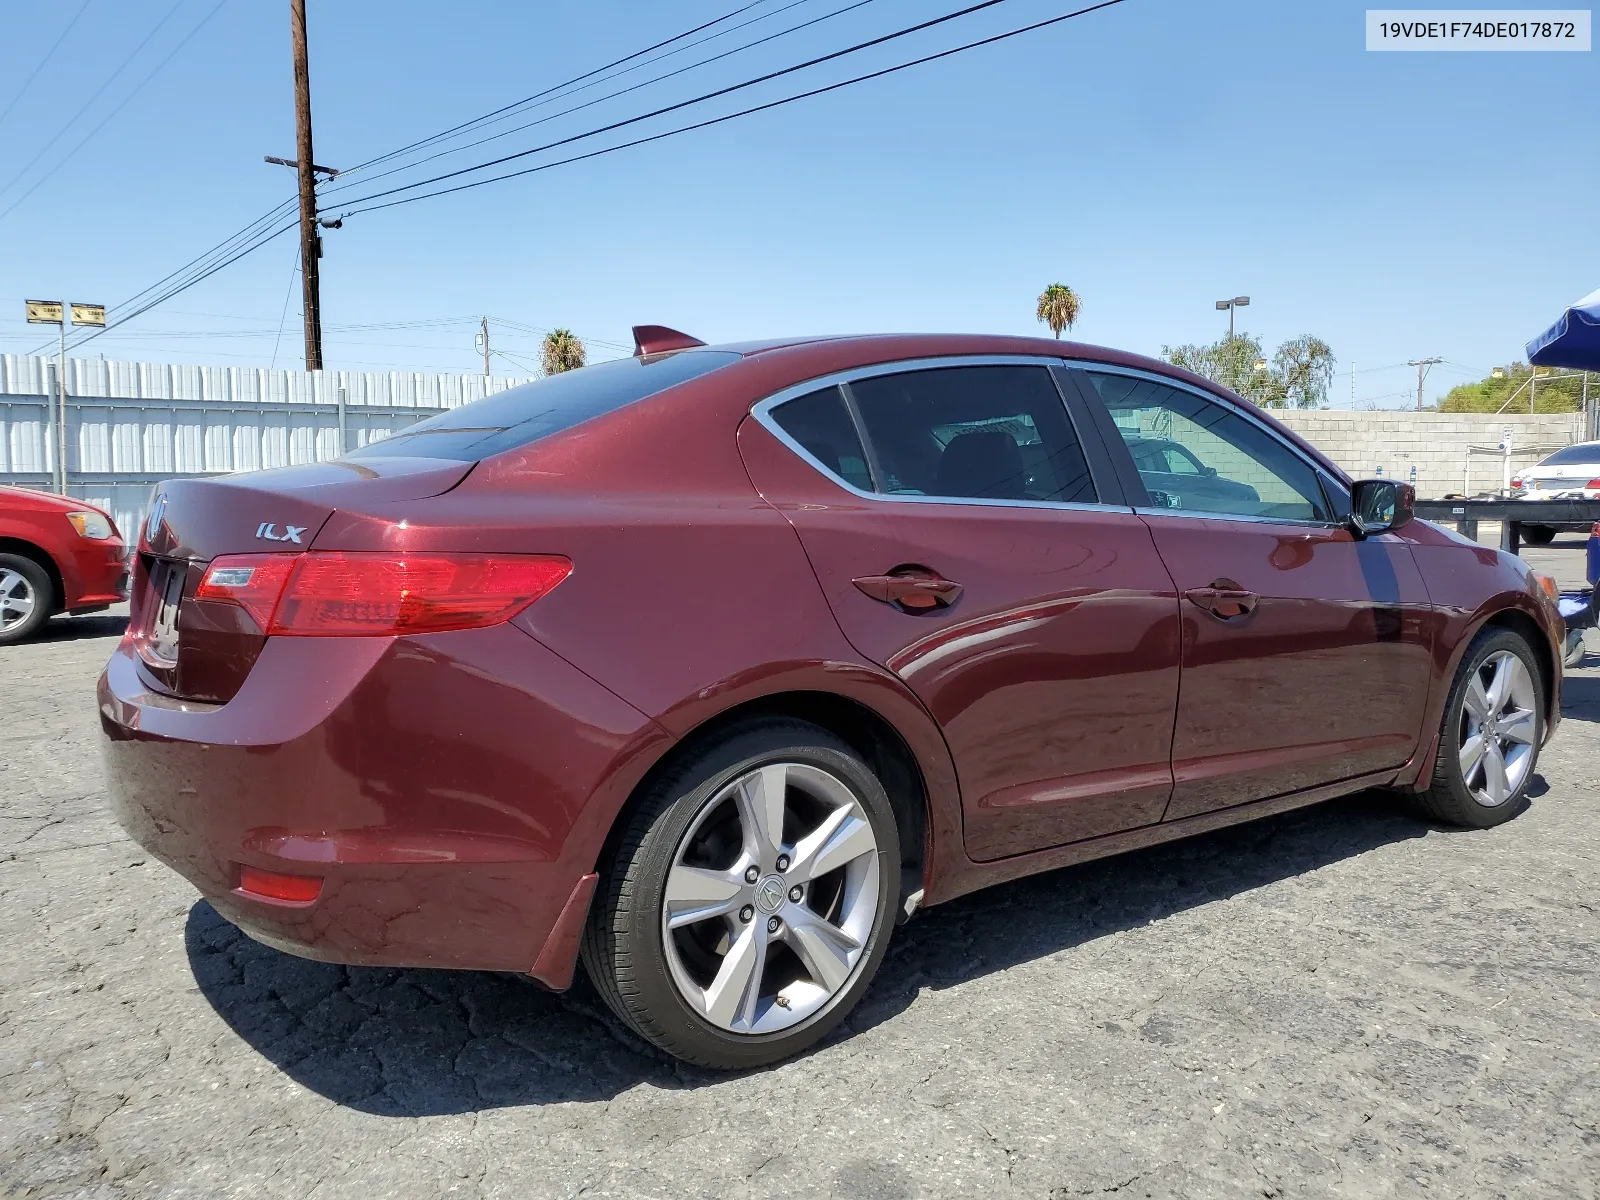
[1272, 408, 1584, 499]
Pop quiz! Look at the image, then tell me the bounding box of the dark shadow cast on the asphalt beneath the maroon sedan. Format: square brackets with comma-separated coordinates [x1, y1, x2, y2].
[186, 794, 1426, 1115]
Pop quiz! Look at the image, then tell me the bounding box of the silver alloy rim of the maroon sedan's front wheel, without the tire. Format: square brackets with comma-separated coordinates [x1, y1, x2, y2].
[1458, 650, 1539, 808]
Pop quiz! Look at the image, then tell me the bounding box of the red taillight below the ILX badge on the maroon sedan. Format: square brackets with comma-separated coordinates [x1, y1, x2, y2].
[195, 552, 573, 637]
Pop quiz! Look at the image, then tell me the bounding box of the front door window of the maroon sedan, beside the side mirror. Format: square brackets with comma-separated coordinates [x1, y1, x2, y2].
[1086, 371, 1331, 522]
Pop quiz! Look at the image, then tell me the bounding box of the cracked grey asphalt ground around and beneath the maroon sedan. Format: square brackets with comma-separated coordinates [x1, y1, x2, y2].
[0, 576, 1600, 1200]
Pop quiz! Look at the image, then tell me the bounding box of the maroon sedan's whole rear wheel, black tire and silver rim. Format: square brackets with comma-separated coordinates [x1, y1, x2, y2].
[582, 718, 901, 1069]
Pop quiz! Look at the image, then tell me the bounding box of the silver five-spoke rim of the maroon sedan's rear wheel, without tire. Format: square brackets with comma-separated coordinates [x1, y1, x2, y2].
[661, 762, 878, 1034]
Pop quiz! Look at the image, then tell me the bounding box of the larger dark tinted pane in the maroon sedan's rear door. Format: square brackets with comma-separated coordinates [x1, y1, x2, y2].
[850, 366, 1096, 504]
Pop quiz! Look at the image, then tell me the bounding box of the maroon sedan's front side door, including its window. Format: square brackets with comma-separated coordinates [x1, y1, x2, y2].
[1072, 366, 1432, 819]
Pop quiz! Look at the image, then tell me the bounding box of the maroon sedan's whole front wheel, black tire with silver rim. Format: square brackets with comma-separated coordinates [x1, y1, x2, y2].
[1418, 629, 1544, 829]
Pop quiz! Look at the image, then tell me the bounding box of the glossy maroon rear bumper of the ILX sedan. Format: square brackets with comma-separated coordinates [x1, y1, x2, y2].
[99, 626, 669, 986]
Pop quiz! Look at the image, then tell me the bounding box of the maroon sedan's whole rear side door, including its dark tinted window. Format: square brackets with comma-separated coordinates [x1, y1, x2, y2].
[739, 360, 1178, 859]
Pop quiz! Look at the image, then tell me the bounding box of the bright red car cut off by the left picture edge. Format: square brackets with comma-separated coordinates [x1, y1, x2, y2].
[0, 486, 128, 645]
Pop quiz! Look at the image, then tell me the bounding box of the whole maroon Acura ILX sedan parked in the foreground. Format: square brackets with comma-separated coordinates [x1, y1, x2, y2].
[99, 328, 1562, 1067]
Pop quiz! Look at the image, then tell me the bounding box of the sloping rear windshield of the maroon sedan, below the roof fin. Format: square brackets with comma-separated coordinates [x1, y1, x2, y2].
[346, 350, 739, 462]
